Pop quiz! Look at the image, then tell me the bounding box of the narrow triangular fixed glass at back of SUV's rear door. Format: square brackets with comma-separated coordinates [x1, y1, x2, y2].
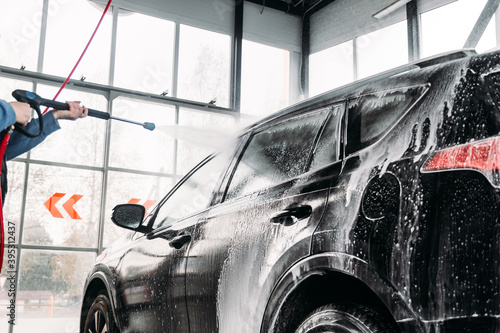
[310, 104, 344, 170]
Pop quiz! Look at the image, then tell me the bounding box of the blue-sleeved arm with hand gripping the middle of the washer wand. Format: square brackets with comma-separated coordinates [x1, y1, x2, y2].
[5, 102, 88, 160]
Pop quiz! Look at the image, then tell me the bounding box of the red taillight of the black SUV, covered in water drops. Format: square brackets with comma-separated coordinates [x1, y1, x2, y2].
[423, 137, 500, 171]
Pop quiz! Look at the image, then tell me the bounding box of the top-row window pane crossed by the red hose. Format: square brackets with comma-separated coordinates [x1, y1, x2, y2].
[43, 0, 112, 84]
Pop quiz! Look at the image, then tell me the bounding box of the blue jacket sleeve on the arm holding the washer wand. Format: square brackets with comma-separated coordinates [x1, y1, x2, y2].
[5, 112, 61, 161]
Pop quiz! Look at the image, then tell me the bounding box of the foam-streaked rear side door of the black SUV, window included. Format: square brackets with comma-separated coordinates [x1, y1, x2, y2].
[186, 105, 343, 333]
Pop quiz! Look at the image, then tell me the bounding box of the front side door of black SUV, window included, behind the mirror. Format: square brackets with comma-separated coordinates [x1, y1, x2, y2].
[116, 154, 227, 332]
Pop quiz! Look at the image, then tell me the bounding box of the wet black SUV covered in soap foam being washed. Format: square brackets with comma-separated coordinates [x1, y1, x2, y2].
[81, 50, 500, 333]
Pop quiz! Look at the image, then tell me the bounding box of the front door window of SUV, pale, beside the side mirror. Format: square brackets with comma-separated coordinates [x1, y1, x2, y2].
[153, 153, 229, 229]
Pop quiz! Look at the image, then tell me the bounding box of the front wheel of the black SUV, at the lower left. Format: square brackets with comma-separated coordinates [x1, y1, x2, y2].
[83, 294, 118, 333]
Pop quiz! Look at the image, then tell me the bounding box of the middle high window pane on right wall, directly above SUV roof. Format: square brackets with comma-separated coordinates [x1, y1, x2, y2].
[356, 21, 408, 78]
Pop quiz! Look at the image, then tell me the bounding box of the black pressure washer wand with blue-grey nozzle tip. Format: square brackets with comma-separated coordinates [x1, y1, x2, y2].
[12, 89, 155, 131]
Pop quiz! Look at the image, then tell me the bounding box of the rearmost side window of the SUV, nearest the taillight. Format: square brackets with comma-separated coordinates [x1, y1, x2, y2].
[346, 86, 428, 155]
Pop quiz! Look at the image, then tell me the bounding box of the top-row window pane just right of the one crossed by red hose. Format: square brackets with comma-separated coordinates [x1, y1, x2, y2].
[114, 10, 175, 94]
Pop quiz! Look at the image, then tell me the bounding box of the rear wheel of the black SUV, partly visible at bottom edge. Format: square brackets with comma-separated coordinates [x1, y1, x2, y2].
[295, 304, 399, 333]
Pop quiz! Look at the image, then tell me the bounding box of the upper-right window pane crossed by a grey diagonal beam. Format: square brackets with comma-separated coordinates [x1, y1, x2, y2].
[421, 0, 496, 57]
